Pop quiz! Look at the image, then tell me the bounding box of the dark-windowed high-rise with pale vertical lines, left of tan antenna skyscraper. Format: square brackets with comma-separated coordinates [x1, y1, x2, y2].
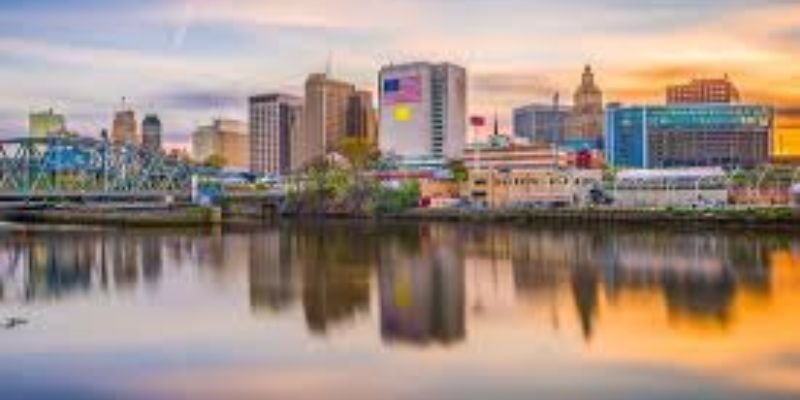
[249, 93, 303, 174]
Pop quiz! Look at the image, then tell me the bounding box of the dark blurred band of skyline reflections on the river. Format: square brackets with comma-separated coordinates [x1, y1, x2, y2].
[0, 223, 800, 345]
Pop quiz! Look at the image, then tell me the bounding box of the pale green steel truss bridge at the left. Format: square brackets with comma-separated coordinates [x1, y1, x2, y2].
[0, 137, 212, 201]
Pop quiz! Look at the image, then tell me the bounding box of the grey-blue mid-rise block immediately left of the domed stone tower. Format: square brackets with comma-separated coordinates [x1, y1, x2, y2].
[513, 104, 570, 143]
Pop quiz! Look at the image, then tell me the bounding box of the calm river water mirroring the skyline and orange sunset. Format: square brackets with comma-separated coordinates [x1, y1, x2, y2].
[0, 223, 800, 400]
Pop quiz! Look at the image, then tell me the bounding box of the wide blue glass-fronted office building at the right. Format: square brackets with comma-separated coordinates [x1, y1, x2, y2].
[605, 104, 774, 168]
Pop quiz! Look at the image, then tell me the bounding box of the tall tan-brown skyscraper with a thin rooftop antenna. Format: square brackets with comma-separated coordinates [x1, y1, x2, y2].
[295, 74, 355, 166]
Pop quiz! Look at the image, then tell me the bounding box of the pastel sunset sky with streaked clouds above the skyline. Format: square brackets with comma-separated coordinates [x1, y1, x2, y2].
[0, 0, 800, 151]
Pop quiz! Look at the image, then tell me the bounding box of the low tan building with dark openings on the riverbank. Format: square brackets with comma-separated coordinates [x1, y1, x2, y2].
[465, 168, 603, 208]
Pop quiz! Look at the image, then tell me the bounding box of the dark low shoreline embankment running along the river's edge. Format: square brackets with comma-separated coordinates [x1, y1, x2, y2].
[0, 206, 800, 231]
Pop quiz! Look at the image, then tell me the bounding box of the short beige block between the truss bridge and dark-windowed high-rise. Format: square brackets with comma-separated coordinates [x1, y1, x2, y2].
[192, 119, 250, 169]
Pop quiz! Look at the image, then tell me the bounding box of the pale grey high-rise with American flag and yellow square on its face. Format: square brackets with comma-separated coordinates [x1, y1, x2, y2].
[378, 62, 467, 160]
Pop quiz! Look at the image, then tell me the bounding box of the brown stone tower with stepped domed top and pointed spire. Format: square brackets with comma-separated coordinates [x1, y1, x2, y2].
[565, 65, 603, 141]
